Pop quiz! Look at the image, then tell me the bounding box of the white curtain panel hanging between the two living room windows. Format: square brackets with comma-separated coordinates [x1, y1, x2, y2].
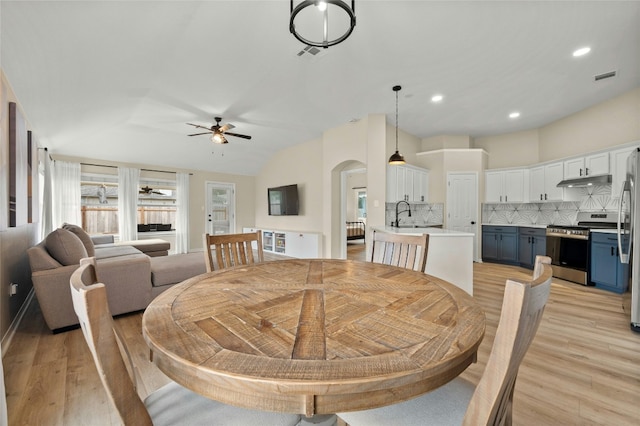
[118, 167, 140, 241]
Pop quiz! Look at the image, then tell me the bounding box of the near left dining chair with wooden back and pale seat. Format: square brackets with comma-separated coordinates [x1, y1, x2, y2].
[70, 258, 301, 426]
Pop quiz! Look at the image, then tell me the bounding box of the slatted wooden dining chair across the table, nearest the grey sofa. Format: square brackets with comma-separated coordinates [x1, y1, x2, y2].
[204, 230, 264, 272]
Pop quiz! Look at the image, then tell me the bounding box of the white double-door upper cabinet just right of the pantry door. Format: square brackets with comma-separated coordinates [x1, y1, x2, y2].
[484, 169, 529, 203]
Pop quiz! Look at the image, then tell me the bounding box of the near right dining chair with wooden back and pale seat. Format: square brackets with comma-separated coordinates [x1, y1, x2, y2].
[338, 256, 552, 426]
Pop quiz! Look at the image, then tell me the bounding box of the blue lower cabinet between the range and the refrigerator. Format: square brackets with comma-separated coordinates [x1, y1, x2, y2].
[590, 232, 629, 293]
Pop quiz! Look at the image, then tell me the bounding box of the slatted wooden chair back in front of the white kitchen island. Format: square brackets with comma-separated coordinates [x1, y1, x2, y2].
[371, 230, 429, 272]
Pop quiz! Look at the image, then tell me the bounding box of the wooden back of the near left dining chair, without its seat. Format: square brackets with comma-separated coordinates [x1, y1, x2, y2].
[70, 258, 152, 425]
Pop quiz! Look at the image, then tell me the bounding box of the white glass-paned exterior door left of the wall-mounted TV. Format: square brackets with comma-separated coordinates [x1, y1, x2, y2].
[205, 182, 236, 234]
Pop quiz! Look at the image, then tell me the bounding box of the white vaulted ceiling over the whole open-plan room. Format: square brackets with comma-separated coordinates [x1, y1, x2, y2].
[0, 0, 640, 175]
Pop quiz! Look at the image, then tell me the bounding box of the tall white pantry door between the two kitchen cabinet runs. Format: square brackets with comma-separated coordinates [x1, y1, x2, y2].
[447, 172, 479, 260]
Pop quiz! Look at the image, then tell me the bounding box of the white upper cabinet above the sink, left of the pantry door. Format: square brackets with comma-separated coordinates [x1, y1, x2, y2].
[387, 164, 429, 203]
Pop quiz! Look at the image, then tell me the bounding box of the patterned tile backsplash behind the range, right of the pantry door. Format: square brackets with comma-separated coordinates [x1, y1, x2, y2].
[482, 185, 618, 225]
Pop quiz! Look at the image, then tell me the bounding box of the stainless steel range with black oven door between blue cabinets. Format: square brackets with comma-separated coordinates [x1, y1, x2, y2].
[547, 212, 618, 285]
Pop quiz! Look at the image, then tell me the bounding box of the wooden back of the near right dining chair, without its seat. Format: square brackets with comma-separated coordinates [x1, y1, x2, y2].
[463, 256, 553, 425]
